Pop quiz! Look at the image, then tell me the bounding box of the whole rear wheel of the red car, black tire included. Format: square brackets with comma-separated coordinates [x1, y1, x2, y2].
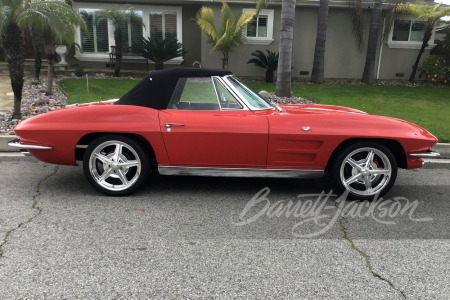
[83, 135, 150, 196]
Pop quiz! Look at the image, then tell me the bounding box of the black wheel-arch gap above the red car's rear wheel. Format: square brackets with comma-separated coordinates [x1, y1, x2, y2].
[75, 132, 157, 169]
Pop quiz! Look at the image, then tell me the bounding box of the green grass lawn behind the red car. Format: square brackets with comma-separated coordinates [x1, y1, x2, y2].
[59, 79, 450, 142]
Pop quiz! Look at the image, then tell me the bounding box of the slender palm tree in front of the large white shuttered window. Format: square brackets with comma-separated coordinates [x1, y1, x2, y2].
[97, 7, 143, 77]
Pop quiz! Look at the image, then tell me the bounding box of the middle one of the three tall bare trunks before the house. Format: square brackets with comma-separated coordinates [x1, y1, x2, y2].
[311, 0, 328, 83]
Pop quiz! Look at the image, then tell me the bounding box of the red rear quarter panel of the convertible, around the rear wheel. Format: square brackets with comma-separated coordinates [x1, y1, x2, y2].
[14, 105, 169, 165]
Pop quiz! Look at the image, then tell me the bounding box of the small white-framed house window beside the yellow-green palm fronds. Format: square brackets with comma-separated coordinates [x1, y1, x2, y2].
[243, 9, 274, 45]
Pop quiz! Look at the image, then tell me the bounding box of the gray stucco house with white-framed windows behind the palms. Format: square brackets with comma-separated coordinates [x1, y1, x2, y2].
[73, 0, 440, 79]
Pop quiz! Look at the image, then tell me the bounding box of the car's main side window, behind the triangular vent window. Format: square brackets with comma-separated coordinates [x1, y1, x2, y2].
[168, 77, 220, 110]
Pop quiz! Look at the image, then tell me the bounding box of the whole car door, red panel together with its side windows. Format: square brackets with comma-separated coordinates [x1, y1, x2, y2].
[159, 78, 268, 168]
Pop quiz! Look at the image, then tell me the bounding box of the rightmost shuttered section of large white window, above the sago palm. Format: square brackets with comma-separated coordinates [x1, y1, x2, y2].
[149, 12, 177, 40]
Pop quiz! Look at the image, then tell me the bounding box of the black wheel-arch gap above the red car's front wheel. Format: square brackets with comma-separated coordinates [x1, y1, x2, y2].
[326, 138, 407, 171]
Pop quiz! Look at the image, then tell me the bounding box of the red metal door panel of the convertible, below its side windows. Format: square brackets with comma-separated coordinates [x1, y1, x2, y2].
[159, 110, 269, 168]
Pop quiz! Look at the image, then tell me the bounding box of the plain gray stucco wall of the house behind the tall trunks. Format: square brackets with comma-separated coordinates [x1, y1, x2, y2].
[201, 3, 429, 79]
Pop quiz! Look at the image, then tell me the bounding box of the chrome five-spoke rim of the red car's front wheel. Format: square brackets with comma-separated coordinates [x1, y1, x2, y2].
[340, 147, 392, 196]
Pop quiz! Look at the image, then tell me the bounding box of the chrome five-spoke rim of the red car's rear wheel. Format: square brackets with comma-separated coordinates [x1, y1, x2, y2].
[89, 141, 141, 191]
